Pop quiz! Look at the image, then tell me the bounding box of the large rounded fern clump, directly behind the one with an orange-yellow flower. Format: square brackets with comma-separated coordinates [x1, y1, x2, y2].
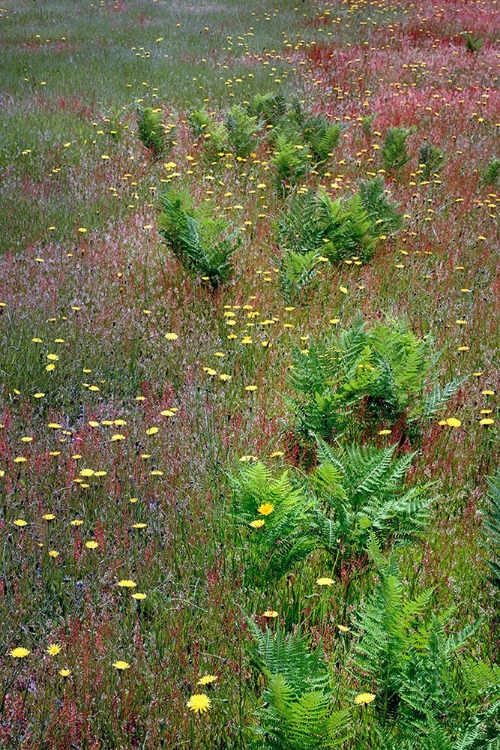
[287, 317, 454, 441]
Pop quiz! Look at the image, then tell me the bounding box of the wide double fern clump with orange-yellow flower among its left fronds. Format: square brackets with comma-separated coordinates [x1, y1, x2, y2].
[231, 440, 431, 587]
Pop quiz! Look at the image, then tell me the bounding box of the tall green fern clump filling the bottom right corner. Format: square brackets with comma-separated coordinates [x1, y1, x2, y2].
[352, 560, 500, 750]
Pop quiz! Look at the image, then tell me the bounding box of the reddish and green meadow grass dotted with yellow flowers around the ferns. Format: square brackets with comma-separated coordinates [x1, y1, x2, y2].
[0, 0, 500, 750]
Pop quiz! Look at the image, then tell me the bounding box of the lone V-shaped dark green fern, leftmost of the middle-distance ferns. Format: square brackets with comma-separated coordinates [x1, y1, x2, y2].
[158, 189, 241, 289]
